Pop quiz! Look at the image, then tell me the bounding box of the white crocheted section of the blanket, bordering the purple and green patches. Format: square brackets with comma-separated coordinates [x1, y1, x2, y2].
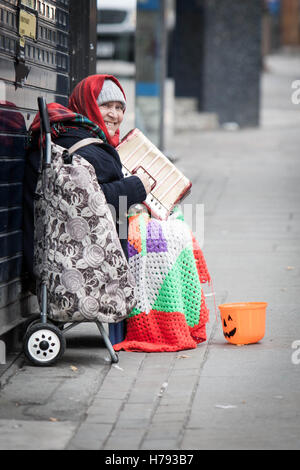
[129, 220, 192, 314]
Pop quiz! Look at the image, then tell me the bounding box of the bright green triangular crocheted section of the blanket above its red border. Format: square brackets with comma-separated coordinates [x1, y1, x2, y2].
[129, 248, 201, 327]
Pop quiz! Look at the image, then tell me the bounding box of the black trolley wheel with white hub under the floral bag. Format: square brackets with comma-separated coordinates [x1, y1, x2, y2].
[24, 323, 66, 366]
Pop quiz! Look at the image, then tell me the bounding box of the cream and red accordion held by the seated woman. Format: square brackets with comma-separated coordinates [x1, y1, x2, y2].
[117, 129, 192, 220]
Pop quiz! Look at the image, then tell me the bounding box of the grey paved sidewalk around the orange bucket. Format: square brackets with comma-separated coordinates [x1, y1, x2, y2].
[0, 49, 300, 450]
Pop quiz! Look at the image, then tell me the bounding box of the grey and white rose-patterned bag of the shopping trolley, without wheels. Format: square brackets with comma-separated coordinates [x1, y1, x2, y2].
[34, 140, 136, 323]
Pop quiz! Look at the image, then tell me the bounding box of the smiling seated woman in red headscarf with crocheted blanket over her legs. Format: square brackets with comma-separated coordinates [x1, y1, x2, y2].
[24, 75, 210, 351]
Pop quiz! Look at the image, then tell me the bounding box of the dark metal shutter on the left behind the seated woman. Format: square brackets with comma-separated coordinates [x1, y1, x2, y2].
[0, 0, 69, 335]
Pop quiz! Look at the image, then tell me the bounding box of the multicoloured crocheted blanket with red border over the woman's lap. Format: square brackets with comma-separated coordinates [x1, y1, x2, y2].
[114, 212, 210, 352]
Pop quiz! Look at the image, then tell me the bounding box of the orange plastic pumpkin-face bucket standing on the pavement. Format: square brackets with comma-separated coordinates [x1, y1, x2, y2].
[219, 302, 268, 345]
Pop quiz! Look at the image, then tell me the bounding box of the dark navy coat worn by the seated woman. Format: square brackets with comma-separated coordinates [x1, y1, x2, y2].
[23, 127, 146, 278]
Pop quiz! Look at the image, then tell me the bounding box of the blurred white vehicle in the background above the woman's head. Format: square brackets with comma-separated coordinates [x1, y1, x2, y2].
[97, 0, 136, 62]
